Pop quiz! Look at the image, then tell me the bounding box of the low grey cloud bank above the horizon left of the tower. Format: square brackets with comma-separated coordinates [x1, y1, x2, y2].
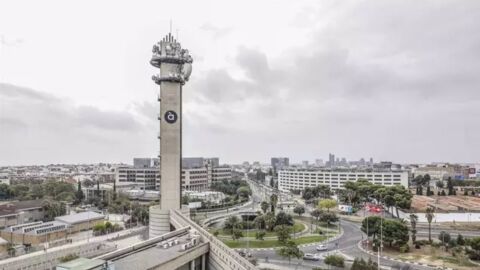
[0, 84, 151, 165]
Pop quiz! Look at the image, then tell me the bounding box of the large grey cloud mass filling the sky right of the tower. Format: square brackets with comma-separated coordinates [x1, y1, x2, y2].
[186, 1, 480, 161]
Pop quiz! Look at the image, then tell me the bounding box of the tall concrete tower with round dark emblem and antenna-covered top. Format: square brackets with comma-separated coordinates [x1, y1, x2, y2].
[150, 33, 193, 237]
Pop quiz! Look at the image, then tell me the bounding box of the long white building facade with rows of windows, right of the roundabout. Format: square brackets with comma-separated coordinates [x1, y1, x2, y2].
[278, 169, 408, 191]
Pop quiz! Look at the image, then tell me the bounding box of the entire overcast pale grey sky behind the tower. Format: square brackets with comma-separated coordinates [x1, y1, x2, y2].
[0, 0, 480, 165]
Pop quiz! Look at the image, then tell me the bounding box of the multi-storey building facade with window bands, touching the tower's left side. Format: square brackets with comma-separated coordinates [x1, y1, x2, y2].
[115, 166, 160, 190]
